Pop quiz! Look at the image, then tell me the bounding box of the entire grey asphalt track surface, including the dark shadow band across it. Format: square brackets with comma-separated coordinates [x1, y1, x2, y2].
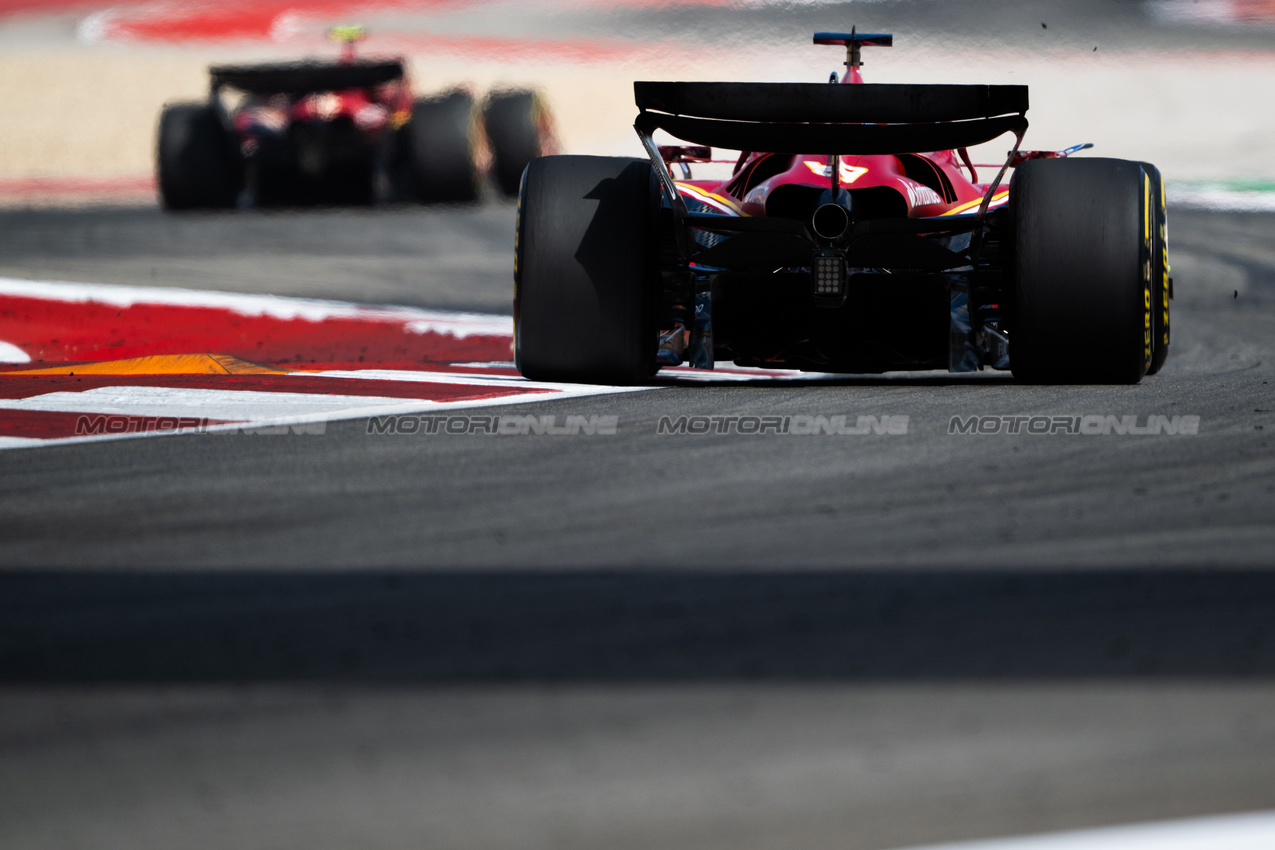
[0, 205, 1275, 849]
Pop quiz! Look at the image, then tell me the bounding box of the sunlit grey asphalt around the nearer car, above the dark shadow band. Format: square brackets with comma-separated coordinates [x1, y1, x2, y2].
[0, 205, 1275, 570]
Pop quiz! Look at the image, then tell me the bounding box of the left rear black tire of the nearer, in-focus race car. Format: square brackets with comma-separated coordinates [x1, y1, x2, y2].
[514, 157, 659, 384]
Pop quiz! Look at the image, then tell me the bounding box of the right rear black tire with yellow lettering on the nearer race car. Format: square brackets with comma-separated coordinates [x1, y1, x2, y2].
[1009, 159, 1153, 384]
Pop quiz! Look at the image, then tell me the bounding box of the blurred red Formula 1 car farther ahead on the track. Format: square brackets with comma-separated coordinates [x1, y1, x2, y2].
[156, 27, 555, 209]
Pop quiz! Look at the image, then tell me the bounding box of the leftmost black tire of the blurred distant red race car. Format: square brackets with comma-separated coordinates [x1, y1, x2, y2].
[156, 103, 244, 209]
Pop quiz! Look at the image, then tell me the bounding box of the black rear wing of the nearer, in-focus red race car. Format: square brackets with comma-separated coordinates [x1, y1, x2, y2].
[634, 82, 1028, 155]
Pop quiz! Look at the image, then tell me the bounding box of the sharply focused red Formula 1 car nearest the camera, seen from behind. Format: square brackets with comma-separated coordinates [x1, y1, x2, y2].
[514, 31, 1172, 384]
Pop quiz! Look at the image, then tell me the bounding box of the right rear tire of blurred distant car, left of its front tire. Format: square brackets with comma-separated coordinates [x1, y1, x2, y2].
[409, 90, 483, 204]
